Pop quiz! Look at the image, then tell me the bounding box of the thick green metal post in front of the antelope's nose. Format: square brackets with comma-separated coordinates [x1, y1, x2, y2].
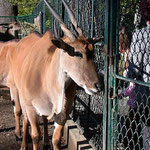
[103, 0, 118, 150]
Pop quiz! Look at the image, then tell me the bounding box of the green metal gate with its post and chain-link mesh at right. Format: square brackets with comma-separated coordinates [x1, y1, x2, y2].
[105, 0, 150, 150]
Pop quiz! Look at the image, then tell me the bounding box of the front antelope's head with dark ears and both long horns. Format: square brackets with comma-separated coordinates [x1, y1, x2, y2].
[44, 0, 100, 95]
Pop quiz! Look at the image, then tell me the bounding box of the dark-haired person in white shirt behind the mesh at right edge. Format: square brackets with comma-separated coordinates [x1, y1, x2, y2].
[122, 0, 150, 150]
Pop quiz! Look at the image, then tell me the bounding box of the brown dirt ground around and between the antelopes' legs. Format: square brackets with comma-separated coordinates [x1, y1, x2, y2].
[0, 89, 54, 150]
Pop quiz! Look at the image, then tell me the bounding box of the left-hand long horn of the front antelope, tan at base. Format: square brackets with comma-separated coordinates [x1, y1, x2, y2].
[44, 0, 76, 41]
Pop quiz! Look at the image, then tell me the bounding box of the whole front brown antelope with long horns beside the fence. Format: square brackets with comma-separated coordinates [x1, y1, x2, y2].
[8, 0, 102, 150]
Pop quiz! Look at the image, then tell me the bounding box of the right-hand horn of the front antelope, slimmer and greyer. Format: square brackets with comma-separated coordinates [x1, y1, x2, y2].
[62, 0, 83, 36]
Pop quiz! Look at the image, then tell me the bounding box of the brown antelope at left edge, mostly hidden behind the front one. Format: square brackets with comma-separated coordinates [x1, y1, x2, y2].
[0, 41, 21, 139]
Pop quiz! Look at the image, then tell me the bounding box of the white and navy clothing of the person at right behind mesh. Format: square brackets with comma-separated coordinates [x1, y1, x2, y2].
[127, 25, 150, 106]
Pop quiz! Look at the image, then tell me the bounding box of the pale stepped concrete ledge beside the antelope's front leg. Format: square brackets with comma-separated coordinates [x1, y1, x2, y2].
[63, 120, 93, 150]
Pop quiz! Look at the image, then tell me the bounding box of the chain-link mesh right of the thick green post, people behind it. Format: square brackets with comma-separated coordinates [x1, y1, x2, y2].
[111, 0, 150, 150]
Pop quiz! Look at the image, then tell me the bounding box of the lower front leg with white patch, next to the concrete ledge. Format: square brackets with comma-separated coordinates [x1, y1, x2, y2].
[52, 122, 63, 150]
